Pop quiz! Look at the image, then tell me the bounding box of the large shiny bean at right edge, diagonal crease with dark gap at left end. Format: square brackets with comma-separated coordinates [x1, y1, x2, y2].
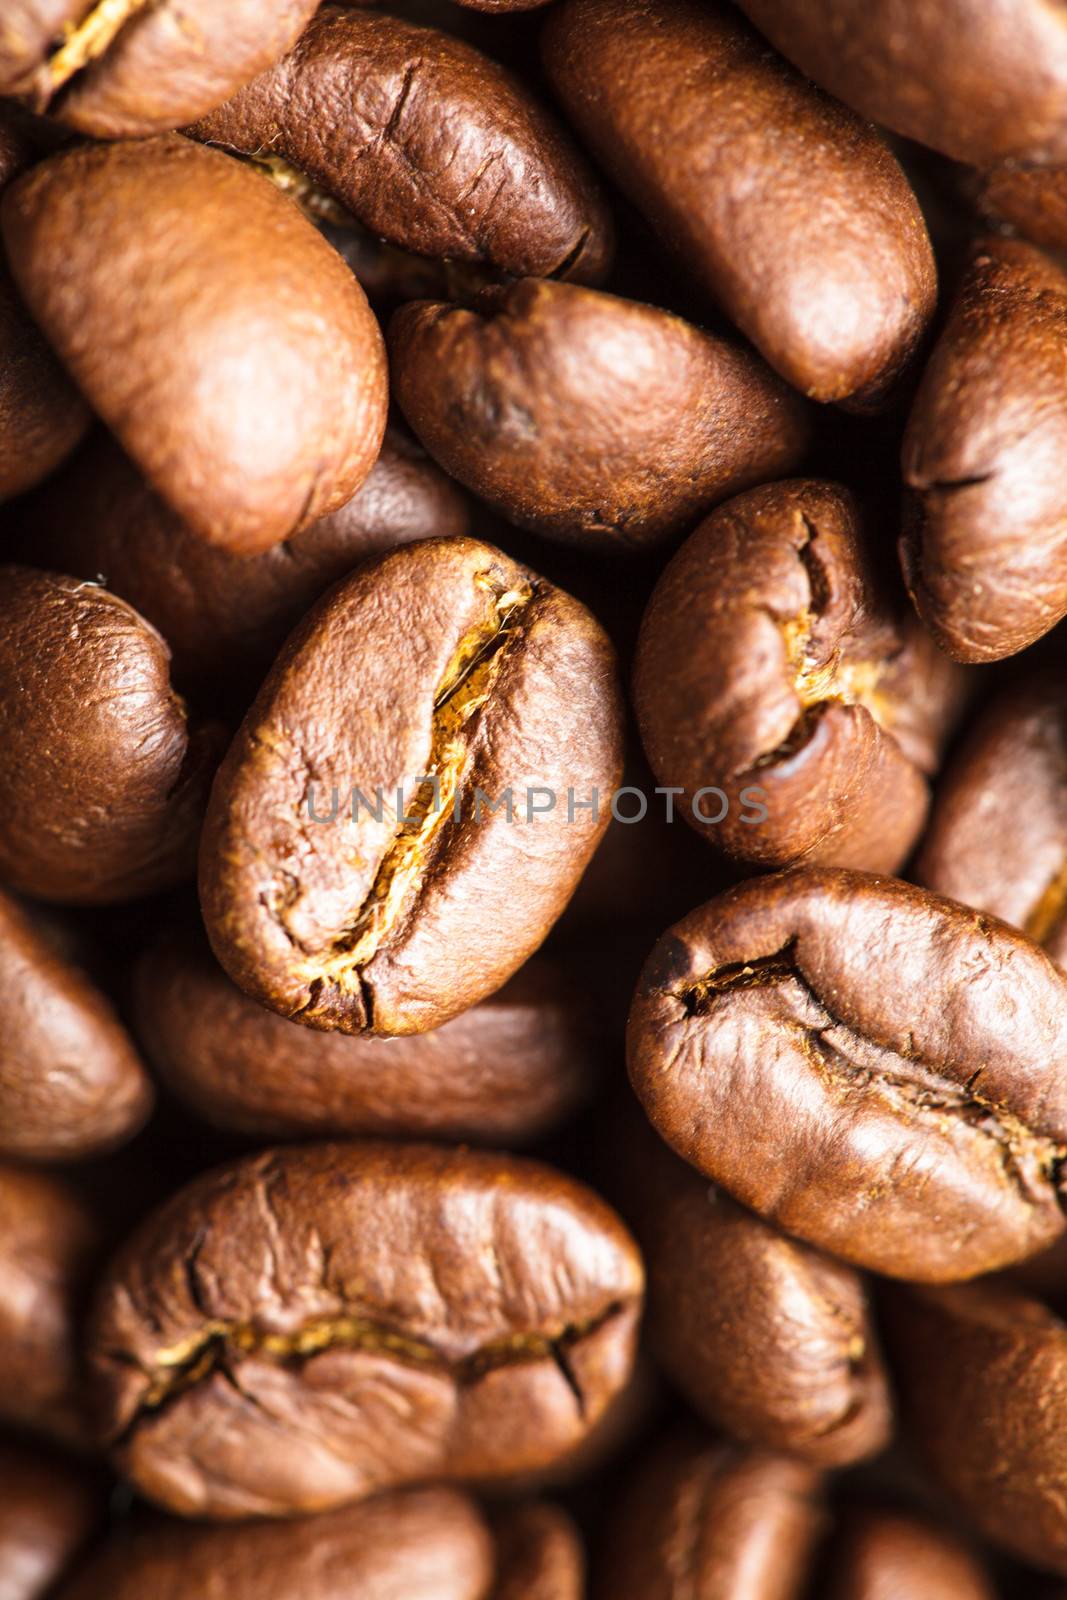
[629, 870, 1067, 1283]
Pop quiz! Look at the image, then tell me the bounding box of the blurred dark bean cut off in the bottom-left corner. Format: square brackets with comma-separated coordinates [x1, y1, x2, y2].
[0, 1443, 101, 1600]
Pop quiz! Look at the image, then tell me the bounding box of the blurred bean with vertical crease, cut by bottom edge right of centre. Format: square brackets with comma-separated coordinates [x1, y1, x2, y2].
[595, 1435, 824, 1600]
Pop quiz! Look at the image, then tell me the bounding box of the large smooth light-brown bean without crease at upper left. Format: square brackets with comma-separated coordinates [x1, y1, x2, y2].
[3, 136, 387, 555]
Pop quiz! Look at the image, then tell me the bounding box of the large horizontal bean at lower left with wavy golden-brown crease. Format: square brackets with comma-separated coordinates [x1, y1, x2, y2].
[90, 1144, 643, 1520]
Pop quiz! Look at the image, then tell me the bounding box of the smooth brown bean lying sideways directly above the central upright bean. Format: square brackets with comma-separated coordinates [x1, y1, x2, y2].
[389, 278, 809, 549]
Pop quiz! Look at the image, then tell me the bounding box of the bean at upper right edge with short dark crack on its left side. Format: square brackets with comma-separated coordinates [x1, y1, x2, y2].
[901, 240, 1067, 661]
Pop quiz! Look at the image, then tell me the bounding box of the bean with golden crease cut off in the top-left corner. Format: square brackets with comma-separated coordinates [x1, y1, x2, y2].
[0, 0, 317, 139]
